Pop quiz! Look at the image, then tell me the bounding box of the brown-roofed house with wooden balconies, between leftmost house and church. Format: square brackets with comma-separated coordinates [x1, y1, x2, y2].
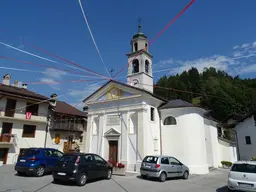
[47, 94, 87, 152]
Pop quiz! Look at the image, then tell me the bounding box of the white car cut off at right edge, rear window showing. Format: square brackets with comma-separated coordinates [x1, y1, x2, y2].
[228, 161, 256, 191]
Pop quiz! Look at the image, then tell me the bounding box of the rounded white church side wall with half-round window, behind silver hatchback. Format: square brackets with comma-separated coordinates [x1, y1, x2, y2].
[161, 108, 209, 174]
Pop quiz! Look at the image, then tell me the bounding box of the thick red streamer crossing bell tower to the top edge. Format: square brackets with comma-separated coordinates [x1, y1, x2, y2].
[113, 0, 195, 78]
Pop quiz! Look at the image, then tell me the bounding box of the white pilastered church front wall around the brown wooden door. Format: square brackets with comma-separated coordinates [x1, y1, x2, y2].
[86, 83, 164, 171]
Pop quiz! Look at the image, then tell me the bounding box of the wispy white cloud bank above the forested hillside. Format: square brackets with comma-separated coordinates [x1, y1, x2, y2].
[153, 41, 256, 75]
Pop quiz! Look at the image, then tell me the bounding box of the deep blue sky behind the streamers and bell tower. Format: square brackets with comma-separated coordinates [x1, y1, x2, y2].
[0, 0, 256, 108]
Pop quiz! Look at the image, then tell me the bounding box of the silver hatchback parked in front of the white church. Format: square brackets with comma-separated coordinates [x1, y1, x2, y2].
[140, 155, 189, 182]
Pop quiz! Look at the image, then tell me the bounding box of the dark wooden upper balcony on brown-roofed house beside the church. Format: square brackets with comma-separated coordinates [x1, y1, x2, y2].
[51, 121, 85, 132]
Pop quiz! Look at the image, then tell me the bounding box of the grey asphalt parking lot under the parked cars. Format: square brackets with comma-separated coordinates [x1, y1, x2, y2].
[0, 165, 228, 192]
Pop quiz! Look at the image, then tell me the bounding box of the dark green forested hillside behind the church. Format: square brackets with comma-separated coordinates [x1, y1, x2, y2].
[154, 68, 256, 121]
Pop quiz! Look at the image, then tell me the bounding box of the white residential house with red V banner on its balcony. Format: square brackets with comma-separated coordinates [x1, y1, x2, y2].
[0, 74, 49, 164]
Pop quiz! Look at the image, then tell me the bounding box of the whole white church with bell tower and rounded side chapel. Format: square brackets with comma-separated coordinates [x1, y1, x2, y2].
[83, 25, 237, 174]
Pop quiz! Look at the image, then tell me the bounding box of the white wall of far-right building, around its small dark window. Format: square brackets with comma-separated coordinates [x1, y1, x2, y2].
[235, 116, 256, 160]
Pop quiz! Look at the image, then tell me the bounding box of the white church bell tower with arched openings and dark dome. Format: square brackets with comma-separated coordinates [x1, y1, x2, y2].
[126, 23, 153, 93]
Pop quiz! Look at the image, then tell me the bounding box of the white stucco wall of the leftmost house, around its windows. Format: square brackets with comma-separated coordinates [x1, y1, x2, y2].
[0, 97, 48, 164]
